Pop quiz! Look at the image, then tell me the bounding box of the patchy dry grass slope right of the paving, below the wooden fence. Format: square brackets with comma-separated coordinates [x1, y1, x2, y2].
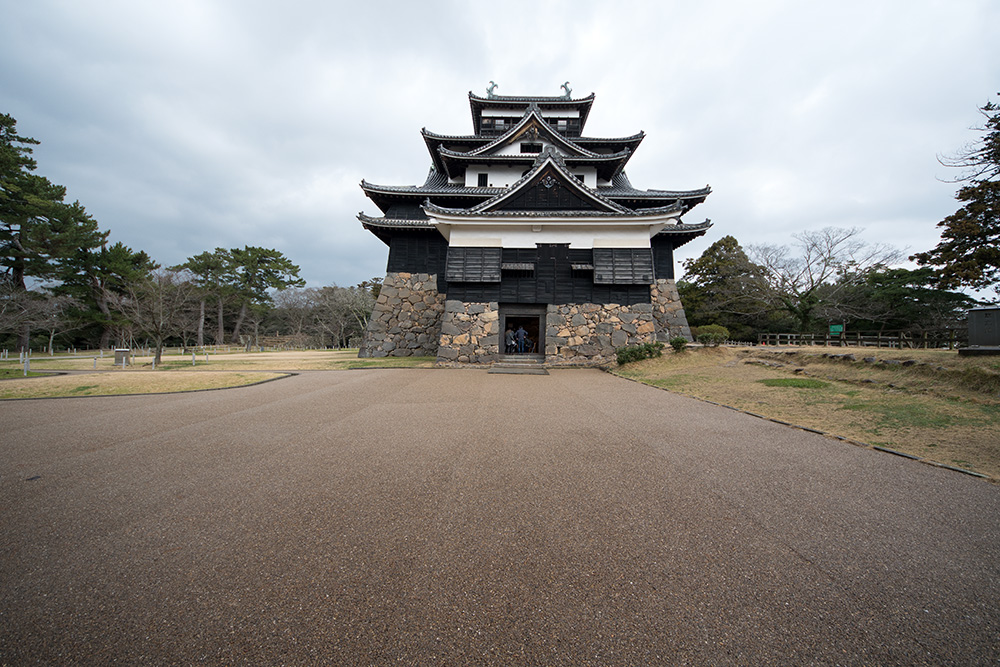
[617, 348, 1000, 479]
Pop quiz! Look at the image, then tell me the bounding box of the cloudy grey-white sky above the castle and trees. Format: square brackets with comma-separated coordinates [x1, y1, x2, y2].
[0, 0, 1000, 287]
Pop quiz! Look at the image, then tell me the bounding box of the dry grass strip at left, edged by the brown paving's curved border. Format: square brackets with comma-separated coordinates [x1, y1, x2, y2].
[0, 371, 286, 399]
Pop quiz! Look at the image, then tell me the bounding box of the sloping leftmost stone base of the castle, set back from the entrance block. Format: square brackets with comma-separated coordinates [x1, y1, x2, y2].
[358, 272, 444, 357]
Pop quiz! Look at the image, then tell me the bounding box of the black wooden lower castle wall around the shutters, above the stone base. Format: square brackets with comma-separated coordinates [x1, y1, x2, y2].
[386, 231, 674, 305]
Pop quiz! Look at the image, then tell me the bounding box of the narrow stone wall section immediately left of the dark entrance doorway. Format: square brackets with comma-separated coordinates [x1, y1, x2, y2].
[437, 300, 500, 366]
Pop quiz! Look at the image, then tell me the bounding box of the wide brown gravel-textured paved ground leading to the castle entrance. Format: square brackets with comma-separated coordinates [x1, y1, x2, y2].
[0, 370, 1000, 665]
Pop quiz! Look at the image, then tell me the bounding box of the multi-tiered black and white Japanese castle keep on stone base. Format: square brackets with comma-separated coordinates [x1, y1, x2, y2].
[358, 85, 711, 366]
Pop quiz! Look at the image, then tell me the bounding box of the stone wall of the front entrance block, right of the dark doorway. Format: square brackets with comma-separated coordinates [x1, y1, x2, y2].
[545, 303, 656, 366]
